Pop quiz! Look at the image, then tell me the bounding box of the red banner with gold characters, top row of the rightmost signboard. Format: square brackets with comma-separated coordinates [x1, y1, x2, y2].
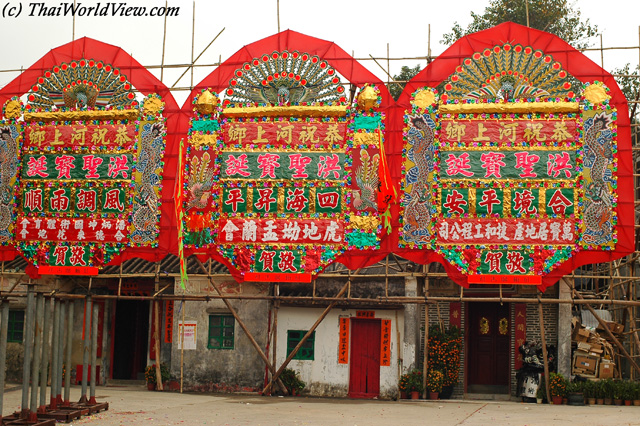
[440, 118, 579, 147]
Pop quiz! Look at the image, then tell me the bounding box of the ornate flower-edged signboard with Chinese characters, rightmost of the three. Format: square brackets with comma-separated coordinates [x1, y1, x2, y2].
[399, 36, 618, 285]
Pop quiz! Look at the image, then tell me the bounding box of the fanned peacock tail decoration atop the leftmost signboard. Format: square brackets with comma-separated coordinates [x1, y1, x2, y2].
[27, 59, 135, 110]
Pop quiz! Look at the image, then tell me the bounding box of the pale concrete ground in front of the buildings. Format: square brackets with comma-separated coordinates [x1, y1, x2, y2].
[4, 385, 640, 426]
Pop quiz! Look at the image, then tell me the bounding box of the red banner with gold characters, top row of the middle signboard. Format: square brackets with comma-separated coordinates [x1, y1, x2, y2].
[222, 118, 347, 148]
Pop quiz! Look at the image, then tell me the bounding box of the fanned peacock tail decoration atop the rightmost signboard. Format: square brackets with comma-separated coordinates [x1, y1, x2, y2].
[442, 43, 574, 101]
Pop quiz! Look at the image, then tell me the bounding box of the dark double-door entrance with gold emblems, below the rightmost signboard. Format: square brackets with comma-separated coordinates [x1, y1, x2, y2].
[467, 303, 511, 394]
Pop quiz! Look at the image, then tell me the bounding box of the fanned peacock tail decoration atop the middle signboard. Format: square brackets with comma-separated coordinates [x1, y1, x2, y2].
[225, 50, 347, 105]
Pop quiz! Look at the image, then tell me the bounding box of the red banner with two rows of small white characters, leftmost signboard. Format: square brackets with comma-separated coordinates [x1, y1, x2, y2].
[15, 217, 127, 243]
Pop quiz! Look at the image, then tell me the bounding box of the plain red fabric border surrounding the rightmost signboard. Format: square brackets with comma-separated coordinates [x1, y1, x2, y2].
[387, 22, 635, 290]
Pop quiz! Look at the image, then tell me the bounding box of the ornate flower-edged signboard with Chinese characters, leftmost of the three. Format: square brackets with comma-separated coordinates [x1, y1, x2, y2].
[0, 59, 166, 274]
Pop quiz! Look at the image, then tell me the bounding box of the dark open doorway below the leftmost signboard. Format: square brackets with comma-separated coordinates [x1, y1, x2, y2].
[112, 300, 149, 380]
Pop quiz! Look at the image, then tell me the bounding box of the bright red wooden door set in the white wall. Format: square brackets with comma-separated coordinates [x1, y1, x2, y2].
[349, 318, 381, 398]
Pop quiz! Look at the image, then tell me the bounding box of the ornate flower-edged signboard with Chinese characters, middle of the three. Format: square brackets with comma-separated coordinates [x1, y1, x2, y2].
[182, 50, 384, 282]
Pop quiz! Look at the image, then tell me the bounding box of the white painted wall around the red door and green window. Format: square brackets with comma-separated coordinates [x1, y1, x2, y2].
[276, 307, 404, 398]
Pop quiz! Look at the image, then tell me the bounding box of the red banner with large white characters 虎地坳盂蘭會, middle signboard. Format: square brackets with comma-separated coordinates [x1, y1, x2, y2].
[218, 219, 344, 244]
